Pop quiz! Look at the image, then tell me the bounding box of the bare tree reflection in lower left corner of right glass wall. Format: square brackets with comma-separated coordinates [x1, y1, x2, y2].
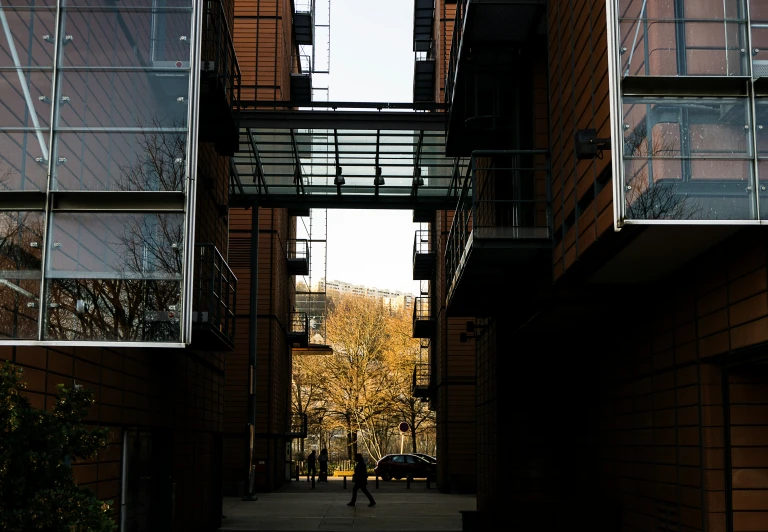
[624, 122, 702, 220]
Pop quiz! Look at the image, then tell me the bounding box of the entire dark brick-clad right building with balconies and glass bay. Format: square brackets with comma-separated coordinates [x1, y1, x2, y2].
[434, 0, 768, 531]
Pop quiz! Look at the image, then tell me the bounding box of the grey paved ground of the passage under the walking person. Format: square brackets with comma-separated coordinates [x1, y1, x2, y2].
[220, 478, 475, 532]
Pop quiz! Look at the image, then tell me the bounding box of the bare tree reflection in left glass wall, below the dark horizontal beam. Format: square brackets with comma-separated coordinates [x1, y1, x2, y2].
[49, 214, 183, 341]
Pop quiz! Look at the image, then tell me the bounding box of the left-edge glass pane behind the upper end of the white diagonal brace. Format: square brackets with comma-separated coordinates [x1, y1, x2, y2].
[0, 7, 56, 68]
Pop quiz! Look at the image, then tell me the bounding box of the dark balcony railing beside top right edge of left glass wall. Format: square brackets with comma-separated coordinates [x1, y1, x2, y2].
[201, 0, 242, 106]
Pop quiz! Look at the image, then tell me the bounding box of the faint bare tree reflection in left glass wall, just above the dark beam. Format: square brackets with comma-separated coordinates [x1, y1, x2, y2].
[117, 117, 187, 191]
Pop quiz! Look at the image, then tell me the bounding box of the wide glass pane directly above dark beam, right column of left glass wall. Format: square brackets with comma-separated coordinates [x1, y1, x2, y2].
[54, 131, 187, 191]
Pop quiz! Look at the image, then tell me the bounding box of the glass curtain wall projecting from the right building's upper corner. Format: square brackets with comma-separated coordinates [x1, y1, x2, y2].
[609, 0, 768, 225]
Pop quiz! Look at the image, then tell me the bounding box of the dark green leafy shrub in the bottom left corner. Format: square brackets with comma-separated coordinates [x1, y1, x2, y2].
[0, 362, 116, 532]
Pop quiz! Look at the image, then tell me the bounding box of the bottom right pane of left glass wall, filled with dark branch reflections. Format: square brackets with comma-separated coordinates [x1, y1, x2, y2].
[44, 279, 181, 342]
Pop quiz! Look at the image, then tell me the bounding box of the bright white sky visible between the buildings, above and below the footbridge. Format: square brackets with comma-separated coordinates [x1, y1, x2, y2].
[313, 0, 419, 294]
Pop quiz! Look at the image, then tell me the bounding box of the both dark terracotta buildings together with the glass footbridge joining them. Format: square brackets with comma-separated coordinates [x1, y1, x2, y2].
[0, 0, 768, 532]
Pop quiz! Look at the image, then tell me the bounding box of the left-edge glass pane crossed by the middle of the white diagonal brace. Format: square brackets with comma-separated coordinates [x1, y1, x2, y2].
[0, 69, 52, 129]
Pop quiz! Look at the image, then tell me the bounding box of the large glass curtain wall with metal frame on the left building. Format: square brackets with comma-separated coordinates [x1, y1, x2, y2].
[0, 0, 200, 345]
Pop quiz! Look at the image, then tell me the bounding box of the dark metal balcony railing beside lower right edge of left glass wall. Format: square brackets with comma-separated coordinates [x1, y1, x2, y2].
[192, 243, 237, 341]
